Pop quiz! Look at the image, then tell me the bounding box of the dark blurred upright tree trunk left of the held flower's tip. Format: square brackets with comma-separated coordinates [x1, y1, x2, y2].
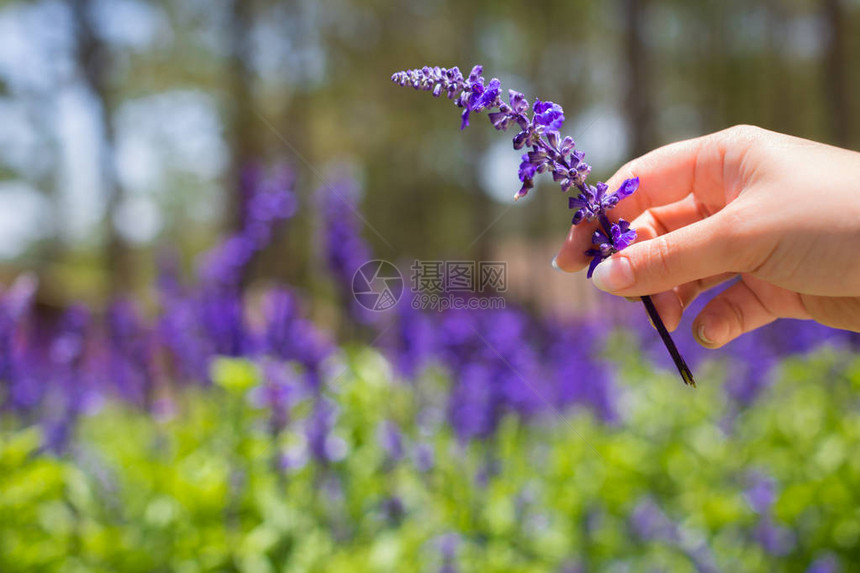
[224, 0, 260, 235]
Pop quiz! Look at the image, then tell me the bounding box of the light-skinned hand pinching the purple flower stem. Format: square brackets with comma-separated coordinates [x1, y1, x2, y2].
[556, 126, 860, 348]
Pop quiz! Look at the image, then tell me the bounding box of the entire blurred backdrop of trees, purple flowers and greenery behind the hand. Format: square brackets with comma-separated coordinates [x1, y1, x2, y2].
[5, 0, 860, 573]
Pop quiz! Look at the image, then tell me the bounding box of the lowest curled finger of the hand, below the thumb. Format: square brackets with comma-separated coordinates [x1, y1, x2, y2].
[693, 275, 811, 348]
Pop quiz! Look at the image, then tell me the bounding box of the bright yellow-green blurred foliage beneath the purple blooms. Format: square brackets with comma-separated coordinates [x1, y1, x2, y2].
[0, 348, 860, 573]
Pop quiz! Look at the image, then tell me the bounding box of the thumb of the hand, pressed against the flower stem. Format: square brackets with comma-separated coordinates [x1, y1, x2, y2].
[592, 209, 749, 296]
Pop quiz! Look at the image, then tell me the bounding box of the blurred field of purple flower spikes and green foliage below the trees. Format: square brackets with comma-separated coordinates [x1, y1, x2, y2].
[0, 165, 860, 573]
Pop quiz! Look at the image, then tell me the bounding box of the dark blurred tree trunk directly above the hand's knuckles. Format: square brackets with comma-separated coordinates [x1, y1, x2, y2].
[622, 0, 655, 156]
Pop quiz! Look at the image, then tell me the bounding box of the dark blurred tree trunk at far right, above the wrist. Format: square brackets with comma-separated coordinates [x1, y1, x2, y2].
[822, 0, 851, 147]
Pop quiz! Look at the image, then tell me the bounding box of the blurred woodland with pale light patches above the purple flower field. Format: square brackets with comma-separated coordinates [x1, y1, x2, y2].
[0, 0, 860, 311]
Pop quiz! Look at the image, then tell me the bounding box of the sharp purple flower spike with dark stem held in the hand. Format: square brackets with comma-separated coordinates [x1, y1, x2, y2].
[391, 65, 696, 386]
